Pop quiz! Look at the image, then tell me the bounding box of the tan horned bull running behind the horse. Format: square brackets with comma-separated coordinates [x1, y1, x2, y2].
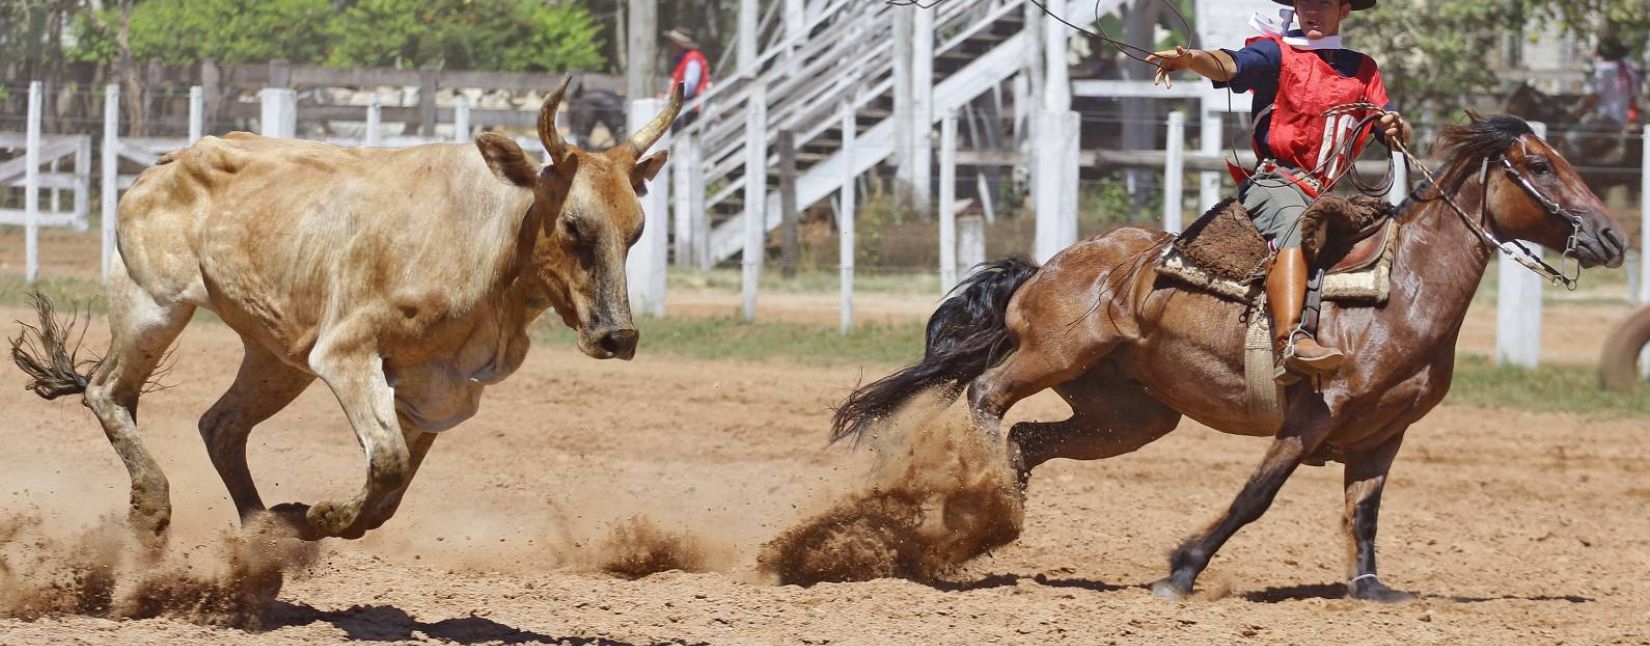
[13, 81, 681, 545]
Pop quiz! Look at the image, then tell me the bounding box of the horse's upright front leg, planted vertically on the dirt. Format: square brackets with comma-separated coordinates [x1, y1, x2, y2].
[1341, 428, 1416, 603]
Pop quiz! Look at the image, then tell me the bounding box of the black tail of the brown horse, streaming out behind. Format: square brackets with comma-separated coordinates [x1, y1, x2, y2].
[830, 257, 1038, 442]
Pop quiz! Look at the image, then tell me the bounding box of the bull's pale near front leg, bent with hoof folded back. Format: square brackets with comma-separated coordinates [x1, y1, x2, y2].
[272, 335, 411, 539]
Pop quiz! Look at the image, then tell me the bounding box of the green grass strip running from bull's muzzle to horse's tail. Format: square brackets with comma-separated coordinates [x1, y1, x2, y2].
[533, 316, 922, 366]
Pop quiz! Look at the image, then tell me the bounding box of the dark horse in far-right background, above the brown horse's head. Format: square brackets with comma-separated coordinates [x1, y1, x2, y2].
[1503, 82, 1645, 193]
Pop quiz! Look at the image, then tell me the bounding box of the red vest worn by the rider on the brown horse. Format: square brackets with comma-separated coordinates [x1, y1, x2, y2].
[1249, 36, 1388, 188]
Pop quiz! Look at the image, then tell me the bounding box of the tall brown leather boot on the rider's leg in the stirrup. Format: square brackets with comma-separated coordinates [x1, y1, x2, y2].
[1266, 249, 1346, 384]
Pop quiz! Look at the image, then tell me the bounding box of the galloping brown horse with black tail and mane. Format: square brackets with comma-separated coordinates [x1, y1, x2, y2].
[833, 117, 1625, 602]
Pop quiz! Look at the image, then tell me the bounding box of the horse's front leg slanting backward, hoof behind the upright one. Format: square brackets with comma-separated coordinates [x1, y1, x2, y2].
[1152, 399, 1330, 600]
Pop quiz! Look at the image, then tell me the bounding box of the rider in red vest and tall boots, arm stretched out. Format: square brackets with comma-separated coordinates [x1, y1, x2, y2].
[1148, 0, 1409, 382]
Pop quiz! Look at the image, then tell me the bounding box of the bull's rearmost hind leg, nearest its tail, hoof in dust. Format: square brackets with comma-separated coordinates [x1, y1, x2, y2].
[86, 271, 195, 549]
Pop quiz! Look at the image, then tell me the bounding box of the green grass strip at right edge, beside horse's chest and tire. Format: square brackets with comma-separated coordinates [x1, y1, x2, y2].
[1444, 354, 1650, 419]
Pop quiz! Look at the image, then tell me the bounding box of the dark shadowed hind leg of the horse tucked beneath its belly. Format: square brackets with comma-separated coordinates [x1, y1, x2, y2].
[1008, 366, 1180, 478]
